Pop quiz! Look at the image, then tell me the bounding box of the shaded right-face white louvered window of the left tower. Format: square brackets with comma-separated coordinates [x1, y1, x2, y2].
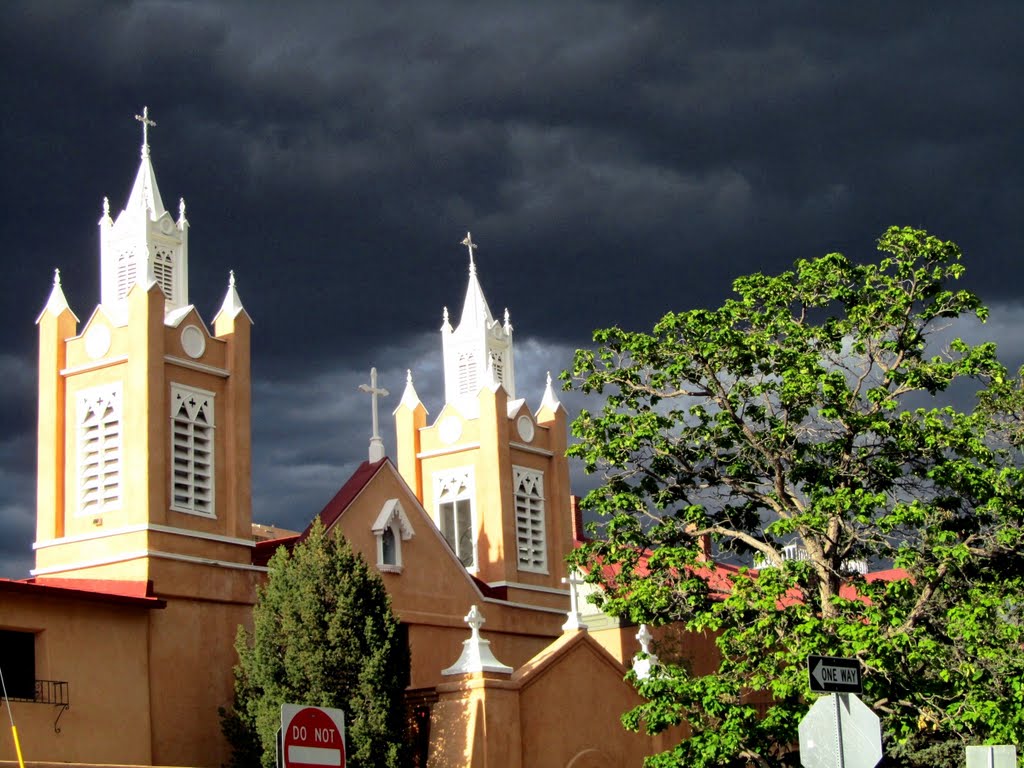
[171, 384, 214, 517]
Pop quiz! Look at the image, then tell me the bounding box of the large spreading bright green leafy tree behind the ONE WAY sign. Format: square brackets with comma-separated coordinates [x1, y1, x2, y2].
[563, 227, 1024, 766]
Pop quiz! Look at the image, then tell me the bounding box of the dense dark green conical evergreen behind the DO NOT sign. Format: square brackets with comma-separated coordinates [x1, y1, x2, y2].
[221, 519, 410, 768]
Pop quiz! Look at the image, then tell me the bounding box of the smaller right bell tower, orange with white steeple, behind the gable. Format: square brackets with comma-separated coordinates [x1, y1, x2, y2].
[394, 233, 571, 609]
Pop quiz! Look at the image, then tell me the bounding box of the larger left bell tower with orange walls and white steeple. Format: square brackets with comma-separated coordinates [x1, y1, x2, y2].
[33, 109, 252, 594]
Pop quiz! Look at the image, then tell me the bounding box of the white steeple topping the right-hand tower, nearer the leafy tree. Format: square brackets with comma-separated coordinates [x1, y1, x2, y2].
[441, 232, 515, 414]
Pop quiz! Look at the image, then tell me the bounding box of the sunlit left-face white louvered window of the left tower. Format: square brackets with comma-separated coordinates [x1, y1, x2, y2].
[78, 384, 121, 515]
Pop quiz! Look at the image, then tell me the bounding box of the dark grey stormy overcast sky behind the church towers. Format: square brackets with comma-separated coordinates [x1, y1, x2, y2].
[0, 0, 1024, 578]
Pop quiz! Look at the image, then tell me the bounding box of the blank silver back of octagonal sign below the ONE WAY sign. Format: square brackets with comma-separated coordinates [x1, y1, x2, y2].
[799, 693, 882, 768]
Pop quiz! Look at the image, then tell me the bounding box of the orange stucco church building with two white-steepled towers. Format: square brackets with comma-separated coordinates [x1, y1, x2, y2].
[0, 110, 696, 768]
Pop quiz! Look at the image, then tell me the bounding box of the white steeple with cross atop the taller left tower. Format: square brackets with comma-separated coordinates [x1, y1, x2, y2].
[99, 108, 188, 312]
